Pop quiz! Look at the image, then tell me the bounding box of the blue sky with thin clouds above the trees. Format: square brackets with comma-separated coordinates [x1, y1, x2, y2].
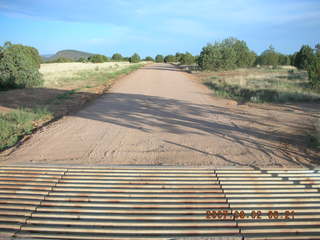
[0, 0, 320, 57]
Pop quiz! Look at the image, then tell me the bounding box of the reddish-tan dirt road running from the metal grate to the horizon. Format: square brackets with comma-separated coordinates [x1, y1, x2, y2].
[1, 64, 319, 167]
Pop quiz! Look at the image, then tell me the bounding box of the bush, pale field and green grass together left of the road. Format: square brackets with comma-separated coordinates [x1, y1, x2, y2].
[0, 42, 144, 151]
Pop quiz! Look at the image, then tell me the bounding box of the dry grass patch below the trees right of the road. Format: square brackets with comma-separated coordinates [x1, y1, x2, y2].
[199, 66, 320, 103]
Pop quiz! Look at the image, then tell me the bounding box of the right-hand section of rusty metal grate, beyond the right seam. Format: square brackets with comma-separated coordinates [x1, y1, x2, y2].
[215, 169, 320, 239]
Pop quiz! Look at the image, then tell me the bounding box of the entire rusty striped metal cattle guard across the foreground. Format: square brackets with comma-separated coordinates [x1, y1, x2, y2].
[0, 166, 320, 239]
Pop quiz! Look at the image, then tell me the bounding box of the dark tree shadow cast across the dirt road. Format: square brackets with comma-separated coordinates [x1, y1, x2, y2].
[76, 93, 319, 167]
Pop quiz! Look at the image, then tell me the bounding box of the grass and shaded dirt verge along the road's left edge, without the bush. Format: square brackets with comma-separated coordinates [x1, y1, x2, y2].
[0, 63, 145, 152]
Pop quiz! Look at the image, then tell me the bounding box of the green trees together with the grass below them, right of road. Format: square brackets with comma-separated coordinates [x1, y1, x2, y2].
[192, 38, 320, 103]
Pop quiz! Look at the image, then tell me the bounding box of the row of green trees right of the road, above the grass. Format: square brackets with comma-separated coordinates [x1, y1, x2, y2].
[197, 38, 320, 89]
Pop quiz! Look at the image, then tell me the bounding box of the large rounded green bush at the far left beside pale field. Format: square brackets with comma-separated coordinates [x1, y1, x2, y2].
[0, 42, 43, 89]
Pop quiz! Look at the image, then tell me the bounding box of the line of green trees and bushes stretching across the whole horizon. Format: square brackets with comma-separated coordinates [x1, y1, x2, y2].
[0, 37, 320, 89]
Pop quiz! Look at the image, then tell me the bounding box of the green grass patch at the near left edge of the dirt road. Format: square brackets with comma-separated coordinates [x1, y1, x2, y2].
[0, 108, 52, 151]
